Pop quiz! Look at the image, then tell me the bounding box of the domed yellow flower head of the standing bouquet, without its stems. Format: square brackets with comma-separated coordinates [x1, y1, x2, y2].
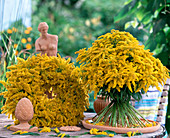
[76, 30, 169, 96]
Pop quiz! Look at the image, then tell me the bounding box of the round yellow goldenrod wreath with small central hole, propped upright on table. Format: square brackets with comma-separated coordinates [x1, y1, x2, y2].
[0, 54, 89, 127]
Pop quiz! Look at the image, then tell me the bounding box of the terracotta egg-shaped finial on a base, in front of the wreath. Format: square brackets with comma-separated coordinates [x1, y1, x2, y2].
[10, 98, 38, 132]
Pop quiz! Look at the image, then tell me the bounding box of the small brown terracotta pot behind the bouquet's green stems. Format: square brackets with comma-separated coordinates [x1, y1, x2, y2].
[93, 95, 109, 114]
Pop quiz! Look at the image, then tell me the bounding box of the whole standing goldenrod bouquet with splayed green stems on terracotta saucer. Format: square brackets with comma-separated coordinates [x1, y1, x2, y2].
[76, 30, 169, 127]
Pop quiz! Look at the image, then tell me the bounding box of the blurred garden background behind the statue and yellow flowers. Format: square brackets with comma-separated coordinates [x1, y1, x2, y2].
[0, 0, 170, 133]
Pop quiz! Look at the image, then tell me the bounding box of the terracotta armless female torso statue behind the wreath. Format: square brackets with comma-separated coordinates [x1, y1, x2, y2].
[35, 22, 58, 56]
